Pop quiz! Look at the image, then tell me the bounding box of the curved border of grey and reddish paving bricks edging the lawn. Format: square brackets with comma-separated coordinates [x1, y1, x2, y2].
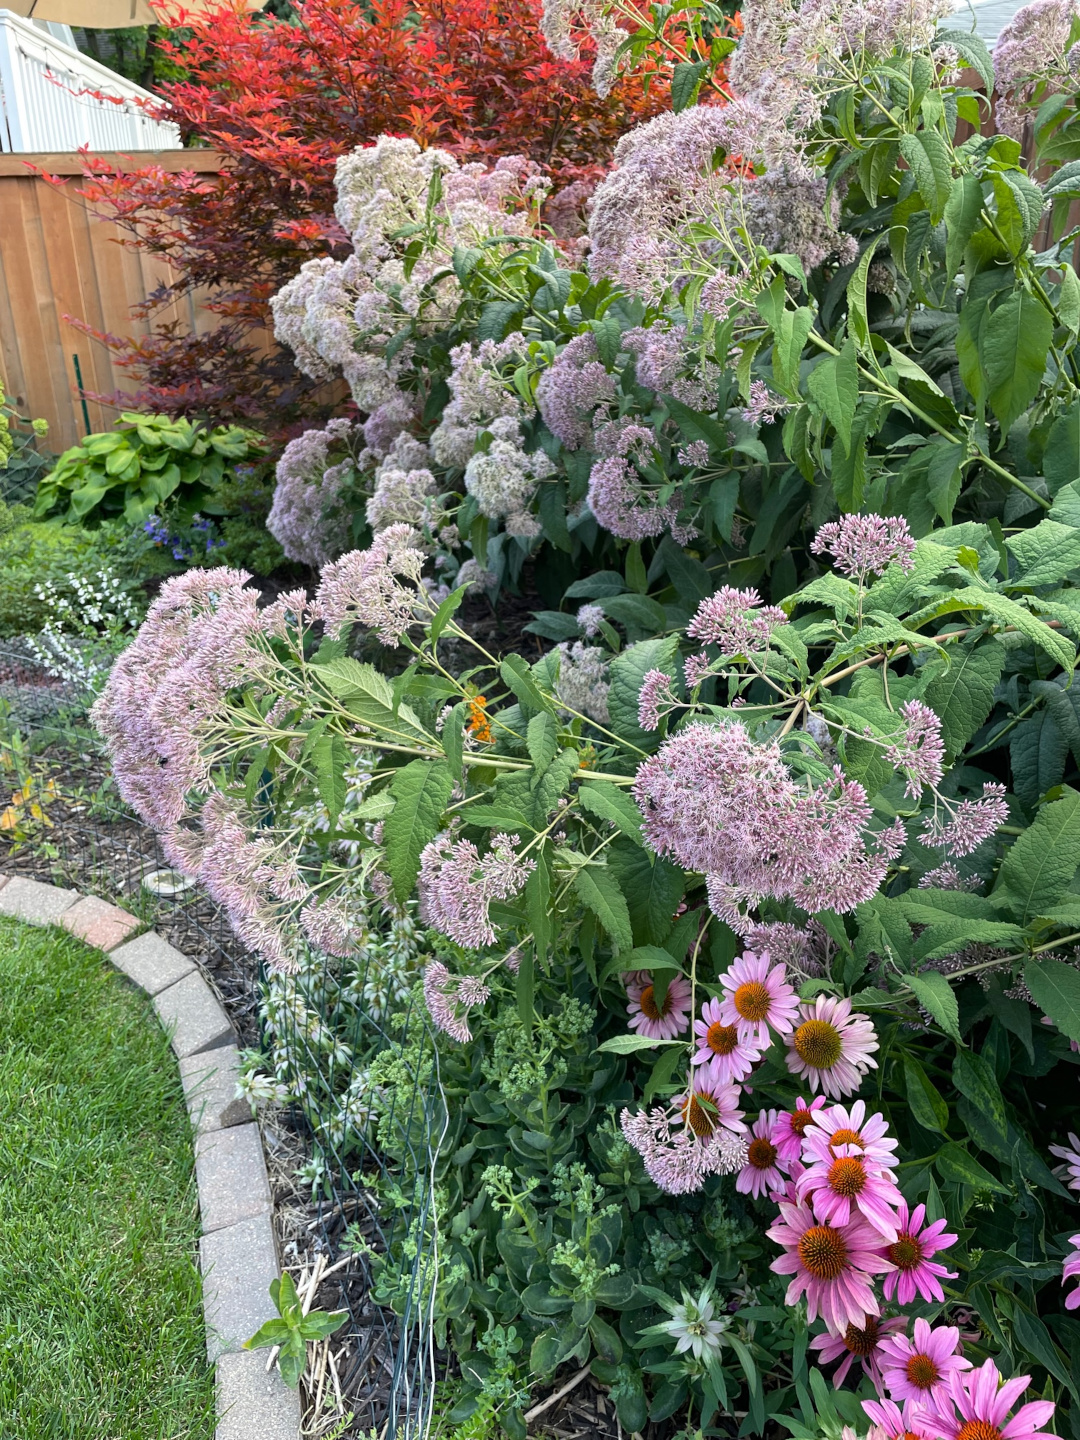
[0, 874, 300, 1440]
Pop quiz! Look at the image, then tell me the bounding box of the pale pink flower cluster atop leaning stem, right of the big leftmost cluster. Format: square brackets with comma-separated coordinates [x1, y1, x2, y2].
[315, 524, 429, 649]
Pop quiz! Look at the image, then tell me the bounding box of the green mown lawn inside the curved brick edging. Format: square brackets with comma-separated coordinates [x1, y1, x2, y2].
[0, 920, 213, 1440]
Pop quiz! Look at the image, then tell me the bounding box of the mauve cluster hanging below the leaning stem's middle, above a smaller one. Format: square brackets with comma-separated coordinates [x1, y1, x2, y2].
[416, 832, 536, 950]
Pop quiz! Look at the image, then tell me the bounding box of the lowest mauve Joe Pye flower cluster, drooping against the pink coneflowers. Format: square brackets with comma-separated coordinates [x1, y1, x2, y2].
[619, 1086, 746, 1195]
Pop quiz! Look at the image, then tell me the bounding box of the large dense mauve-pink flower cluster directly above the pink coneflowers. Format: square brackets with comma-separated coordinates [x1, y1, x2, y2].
[634, 721, 904, 922]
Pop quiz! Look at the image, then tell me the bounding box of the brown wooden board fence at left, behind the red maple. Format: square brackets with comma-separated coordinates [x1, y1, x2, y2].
[0, 150, 247, 451]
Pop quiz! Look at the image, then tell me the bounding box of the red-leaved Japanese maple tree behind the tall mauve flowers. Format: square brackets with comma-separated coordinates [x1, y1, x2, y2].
[65, 0, 667, 423]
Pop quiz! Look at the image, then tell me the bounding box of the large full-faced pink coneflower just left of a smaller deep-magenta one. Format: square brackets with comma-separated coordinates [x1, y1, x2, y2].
[768, 1201, 893, 1335]
